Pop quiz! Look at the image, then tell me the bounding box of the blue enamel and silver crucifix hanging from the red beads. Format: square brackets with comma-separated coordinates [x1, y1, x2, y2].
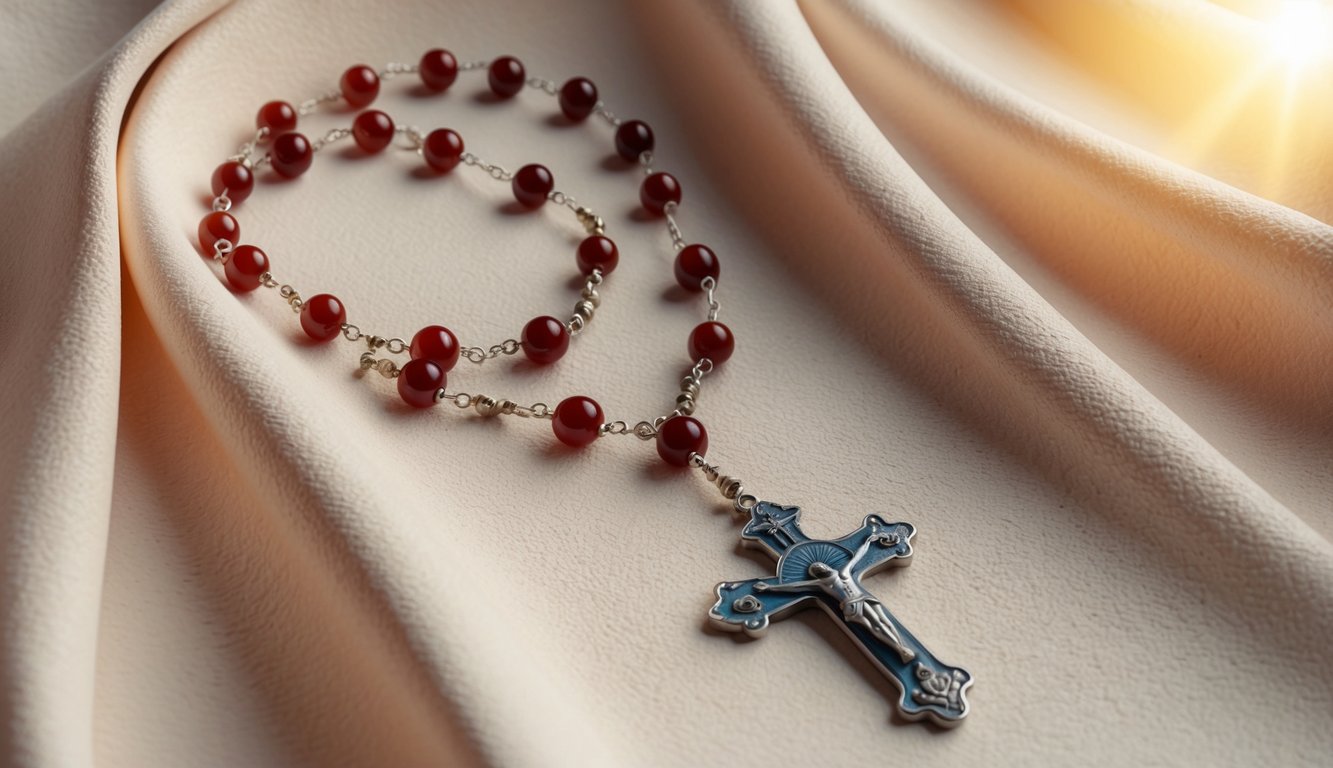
[709, 501, 972, 725]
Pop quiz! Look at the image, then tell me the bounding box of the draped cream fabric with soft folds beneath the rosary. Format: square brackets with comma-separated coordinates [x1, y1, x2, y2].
[0, 0, 1333, 765]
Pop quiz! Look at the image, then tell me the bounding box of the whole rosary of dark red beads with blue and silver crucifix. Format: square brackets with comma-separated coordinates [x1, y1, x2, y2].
[199, 49, 972, 727]
